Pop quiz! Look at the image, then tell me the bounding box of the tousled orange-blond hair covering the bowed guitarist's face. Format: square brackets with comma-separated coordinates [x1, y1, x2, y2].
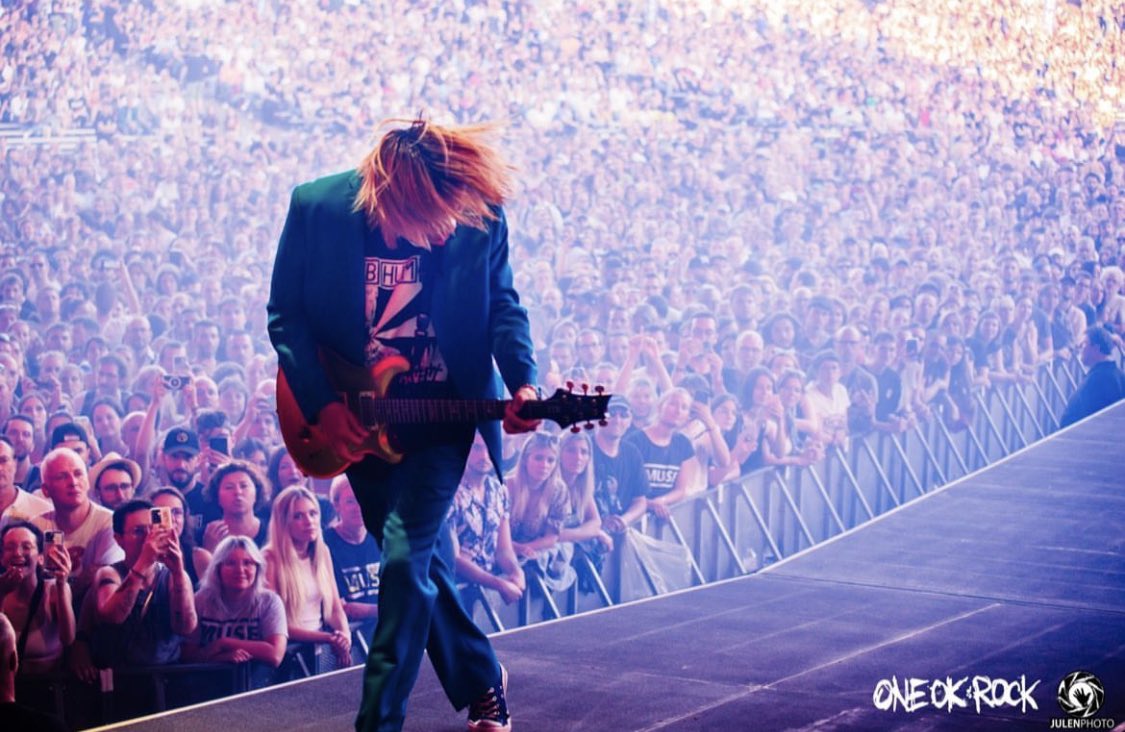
[352, 117, 512, 248]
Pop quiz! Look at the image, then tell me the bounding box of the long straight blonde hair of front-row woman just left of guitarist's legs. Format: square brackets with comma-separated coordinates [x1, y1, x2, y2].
[264, 486, 339, 621]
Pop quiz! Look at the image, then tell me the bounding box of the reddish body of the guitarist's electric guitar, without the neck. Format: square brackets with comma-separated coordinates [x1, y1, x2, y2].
[278, 351, 410, 478]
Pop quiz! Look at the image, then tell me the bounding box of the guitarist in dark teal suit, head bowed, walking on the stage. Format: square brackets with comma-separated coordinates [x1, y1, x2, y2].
[268, 119, 538, 731]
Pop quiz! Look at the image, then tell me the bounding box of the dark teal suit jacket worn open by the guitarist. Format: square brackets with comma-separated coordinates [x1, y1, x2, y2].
[267, 171, 536, 466]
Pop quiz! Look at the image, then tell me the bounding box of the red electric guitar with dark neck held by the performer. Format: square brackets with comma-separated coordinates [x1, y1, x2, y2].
[277, 349, 610, 478]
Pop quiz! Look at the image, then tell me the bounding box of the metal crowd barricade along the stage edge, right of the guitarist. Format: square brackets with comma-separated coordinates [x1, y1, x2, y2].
[465, 358, 1083, 630]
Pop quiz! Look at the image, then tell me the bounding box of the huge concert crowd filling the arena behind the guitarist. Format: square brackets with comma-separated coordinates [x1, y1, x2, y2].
[0, 0, 1125, 728]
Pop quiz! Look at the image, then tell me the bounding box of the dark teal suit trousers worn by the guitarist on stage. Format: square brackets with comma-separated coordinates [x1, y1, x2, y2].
[348, 426, 500, 732]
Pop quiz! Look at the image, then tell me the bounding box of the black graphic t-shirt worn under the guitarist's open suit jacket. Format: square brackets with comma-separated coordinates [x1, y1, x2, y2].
[363, 247, 448, 385]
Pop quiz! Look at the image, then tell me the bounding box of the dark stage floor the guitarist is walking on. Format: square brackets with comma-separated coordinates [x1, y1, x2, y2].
[99, 404, 1125, 732]
